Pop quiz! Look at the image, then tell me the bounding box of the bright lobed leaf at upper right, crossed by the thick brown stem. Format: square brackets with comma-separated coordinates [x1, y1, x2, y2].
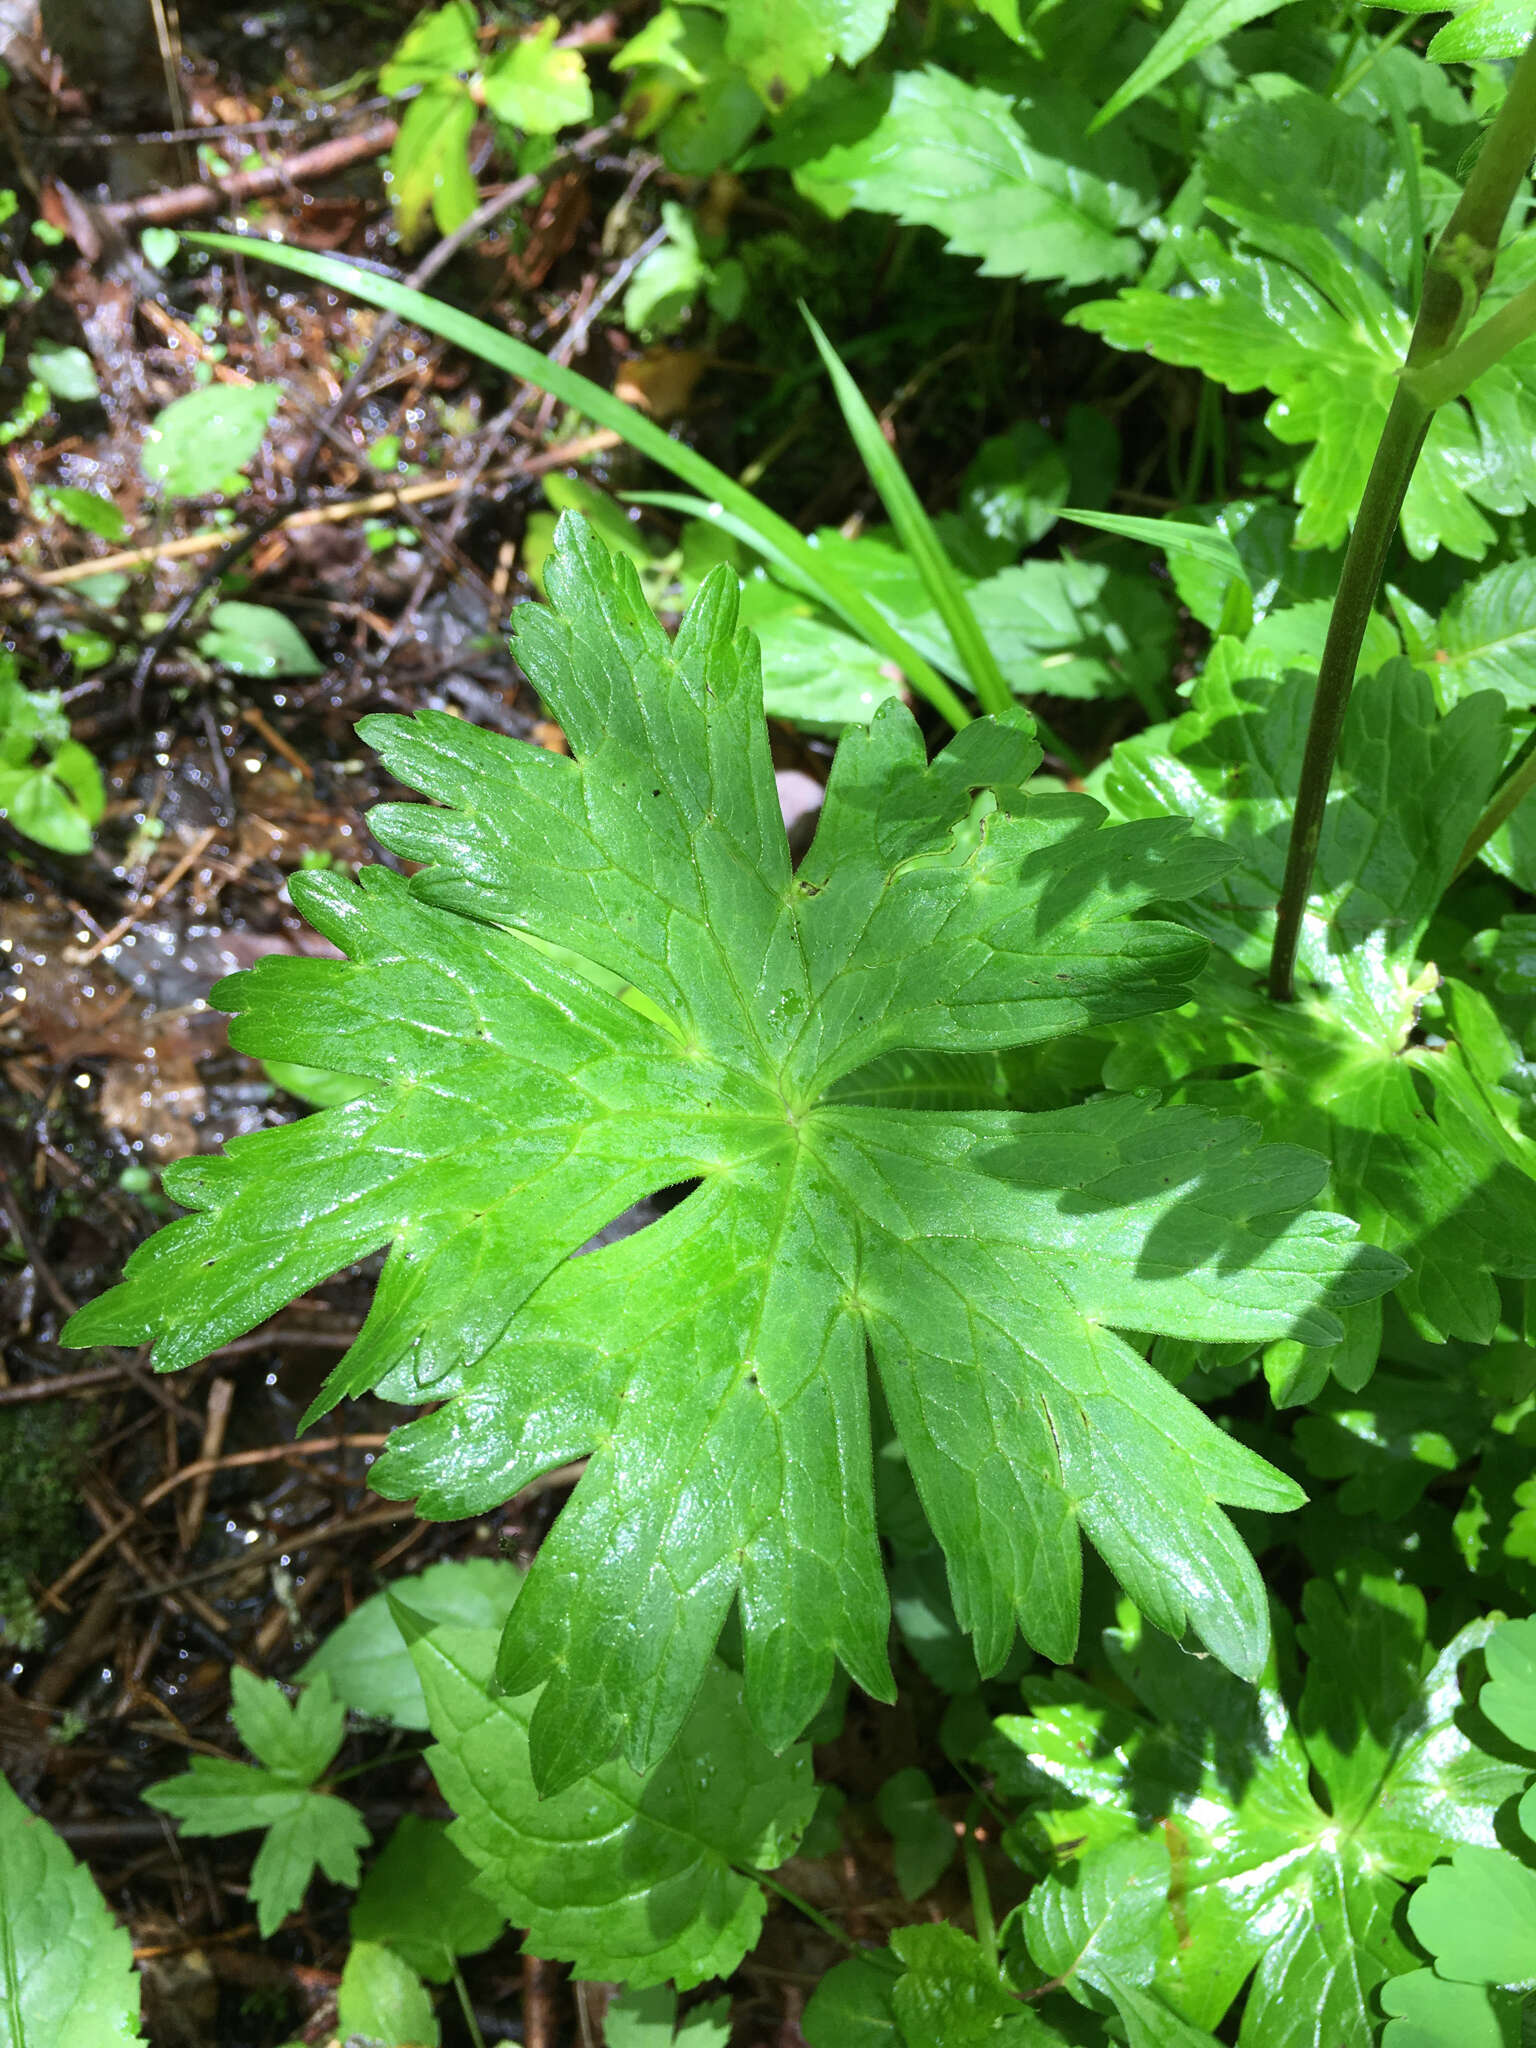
[1069, 90, 1536, 559]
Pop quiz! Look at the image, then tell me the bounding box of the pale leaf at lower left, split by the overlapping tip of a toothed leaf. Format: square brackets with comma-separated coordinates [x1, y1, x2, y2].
[299, 1556, 522, 1731]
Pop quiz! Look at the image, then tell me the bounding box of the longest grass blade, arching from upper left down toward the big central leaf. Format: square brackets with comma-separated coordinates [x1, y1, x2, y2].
[182, 233, 974, 729]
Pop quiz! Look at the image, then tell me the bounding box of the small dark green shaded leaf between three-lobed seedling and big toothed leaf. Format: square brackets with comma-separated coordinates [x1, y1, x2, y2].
[352, 1810, 506, 1985]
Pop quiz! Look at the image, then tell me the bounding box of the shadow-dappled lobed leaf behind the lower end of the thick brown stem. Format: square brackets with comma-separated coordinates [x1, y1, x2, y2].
[1106, 651, 1536, 1399]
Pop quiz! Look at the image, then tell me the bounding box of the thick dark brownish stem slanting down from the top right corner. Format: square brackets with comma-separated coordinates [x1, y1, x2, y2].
[1270, 35, 1536, 1004]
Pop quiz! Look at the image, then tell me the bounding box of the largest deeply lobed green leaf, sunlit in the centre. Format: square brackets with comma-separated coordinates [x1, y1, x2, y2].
[72, 520, 1401, 1786]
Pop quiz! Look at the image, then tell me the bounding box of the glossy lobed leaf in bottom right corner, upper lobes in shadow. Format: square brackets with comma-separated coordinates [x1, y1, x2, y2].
[985, 1565, 1522, 2048]
